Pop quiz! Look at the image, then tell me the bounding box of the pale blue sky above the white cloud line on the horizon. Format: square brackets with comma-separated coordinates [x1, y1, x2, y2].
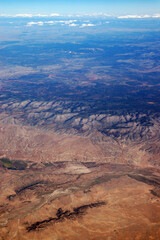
[0, 0, 160, 15]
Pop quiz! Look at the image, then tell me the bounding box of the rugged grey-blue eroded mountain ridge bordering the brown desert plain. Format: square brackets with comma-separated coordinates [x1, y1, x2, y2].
[0, 100, 160, 142]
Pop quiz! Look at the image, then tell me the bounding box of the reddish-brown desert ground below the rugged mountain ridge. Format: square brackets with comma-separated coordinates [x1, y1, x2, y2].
[0, 115, 160, 240]
